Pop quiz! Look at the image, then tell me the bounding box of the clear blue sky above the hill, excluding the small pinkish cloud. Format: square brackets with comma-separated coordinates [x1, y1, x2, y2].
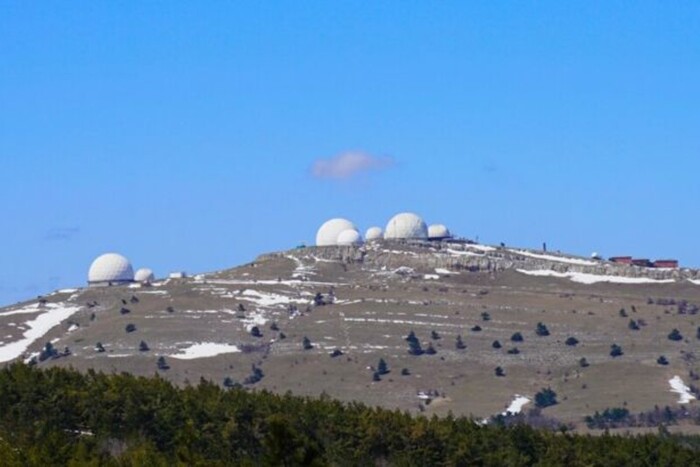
[0, 1, 700, 304]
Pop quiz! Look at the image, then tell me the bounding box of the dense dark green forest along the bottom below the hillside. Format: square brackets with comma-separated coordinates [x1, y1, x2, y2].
[0, 364, 700, 466]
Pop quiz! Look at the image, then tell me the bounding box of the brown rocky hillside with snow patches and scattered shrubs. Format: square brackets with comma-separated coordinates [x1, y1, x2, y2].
[0, 242, 700, 432]
